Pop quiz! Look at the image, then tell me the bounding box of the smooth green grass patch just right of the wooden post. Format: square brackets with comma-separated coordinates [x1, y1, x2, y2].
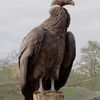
[62, 87, 91, 100]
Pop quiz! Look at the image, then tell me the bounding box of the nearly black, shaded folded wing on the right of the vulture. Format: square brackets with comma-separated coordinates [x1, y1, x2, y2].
[55, 32, 76, 90]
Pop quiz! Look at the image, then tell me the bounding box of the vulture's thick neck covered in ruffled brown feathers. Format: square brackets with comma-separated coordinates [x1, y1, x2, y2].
[41, 7, 67, 34]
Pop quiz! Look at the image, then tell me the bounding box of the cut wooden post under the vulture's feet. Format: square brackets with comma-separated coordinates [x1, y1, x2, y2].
[33, 91, 64, 100]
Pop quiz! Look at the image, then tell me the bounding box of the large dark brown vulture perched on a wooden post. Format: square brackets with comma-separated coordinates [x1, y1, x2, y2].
[19, 0, 75, 100]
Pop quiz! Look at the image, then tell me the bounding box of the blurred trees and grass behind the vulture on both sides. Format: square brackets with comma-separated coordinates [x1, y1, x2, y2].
[0, 41, 100, 100]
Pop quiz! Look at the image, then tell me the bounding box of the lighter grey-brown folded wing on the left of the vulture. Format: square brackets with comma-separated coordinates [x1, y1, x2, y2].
[19, 27, 44, 89]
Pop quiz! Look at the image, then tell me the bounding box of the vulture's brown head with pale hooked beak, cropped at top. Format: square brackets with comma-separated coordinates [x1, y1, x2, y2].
[51, 0, 75, 6]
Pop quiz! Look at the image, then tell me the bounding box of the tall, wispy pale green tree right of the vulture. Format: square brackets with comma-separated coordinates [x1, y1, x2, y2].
[80, 41, 100, 78]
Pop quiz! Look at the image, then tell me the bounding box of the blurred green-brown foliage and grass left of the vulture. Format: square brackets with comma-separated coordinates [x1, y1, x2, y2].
[0, 64, 22, 100]
